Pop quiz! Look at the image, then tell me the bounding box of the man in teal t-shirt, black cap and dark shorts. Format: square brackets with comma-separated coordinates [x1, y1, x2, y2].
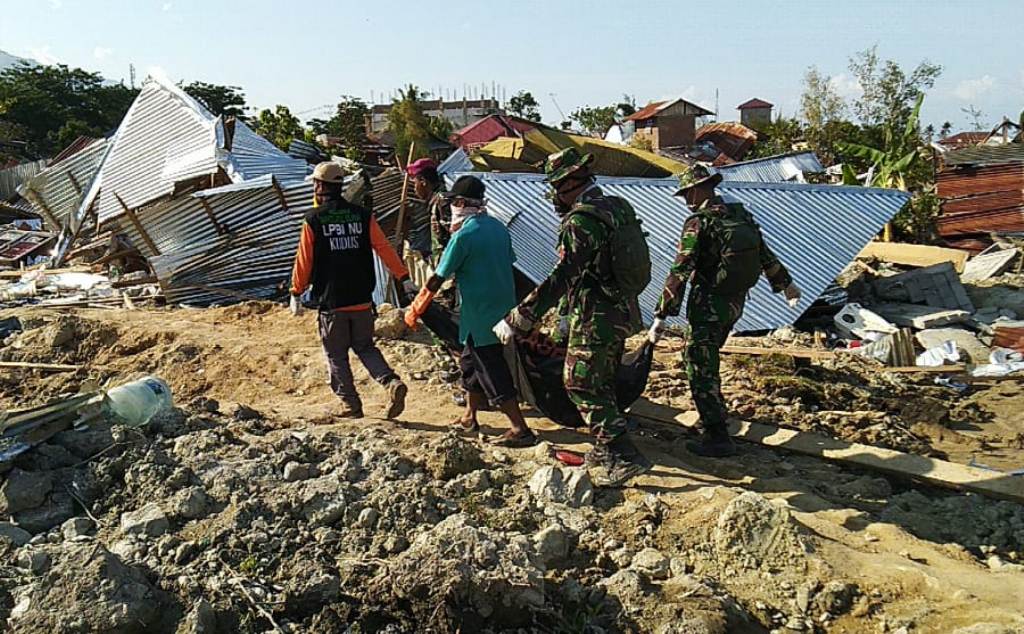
[406, 176, 537, 447]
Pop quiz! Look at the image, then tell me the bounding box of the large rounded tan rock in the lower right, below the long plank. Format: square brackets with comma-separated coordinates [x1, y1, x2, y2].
[714, 492, 808, 568]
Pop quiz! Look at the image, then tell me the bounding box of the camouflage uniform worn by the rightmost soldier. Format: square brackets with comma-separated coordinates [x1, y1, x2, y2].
[655, 197, 793, 431]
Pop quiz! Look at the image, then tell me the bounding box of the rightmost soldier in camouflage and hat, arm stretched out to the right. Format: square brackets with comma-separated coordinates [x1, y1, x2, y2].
[650, 167, 800, 457]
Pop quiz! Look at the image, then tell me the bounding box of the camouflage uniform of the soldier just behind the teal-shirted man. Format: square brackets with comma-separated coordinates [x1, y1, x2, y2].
[518, 185, 640, 440]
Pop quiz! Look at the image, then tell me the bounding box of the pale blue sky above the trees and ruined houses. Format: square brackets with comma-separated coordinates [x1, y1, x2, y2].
[0, 0, 1024, 129]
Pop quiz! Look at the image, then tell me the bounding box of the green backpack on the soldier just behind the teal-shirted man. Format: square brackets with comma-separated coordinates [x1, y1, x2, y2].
[570, 196, 650, 298]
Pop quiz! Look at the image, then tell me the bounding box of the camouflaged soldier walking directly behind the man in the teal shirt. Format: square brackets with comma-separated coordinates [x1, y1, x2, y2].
[495, 147, 651, 485]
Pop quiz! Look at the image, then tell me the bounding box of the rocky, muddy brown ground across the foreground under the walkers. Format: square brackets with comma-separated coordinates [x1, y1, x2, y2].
[0, 302, 1024, 634]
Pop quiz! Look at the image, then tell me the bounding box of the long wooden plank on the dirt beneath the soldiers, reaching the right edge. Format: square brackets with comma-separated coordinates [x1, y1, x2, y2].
[630, 400, 1024, 503]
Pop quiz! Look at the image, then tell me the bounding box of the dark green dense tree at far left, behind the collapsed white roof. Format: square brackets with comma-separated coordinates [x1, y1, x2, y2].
[0, 64, 138, 157]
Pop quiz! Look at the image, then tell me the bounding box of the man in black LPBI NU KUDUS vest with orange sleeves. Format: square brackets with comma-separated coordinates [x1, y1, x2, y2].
[290, 163, 409, 418]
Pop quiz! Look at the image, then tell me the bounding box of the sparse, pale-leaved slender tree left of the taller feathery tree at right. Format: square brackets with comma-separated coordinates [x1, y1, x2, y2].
[800, 66, 857, 165]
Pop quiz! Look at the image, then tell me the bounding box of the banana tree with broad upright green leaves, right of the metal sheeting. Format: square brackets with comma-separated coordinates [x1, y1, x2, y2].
[839, 94, 925, 192]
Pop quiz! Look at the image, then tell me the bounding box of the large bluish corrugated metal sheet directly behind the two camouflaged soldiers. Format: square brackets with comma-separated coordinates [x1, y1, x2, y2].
[446, 173, 909, 331]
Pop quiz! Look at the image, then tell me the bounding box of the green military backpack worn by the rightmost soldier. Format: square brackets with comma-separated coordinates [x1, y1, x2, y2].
[698, 204, 762, 295]
